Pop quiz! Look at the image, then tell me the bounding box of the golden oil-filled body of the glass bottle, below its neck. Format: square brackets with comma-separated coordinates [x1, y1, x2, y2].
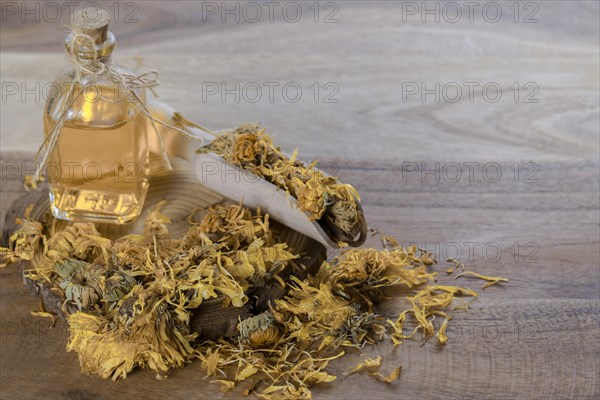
[44, 20, 148, 224]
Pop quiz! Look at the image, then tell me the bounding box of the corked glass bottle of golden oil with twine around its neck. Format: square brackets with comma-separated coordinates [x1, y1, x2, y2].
[44, 11, 148, 224]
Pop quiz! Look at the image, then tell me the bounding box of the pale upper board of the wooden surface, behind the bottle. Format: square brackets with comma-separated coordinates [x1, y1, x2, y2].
[0, 0, 600, 161]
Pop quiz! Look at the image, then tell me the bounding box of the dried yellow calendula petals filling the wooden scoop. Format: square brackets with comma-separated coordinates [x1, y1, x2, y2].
[198, 124, 362, 242]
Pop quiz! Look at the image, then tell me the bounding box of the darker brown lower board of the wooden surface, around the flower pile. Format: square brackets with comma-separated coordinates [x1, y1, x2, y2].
[0, 155, 600, 399]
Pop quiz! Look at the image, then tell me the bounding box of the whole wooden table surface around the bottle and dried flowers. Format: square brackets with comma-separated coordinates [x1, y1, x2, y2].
[0, 1, 600, 399]
